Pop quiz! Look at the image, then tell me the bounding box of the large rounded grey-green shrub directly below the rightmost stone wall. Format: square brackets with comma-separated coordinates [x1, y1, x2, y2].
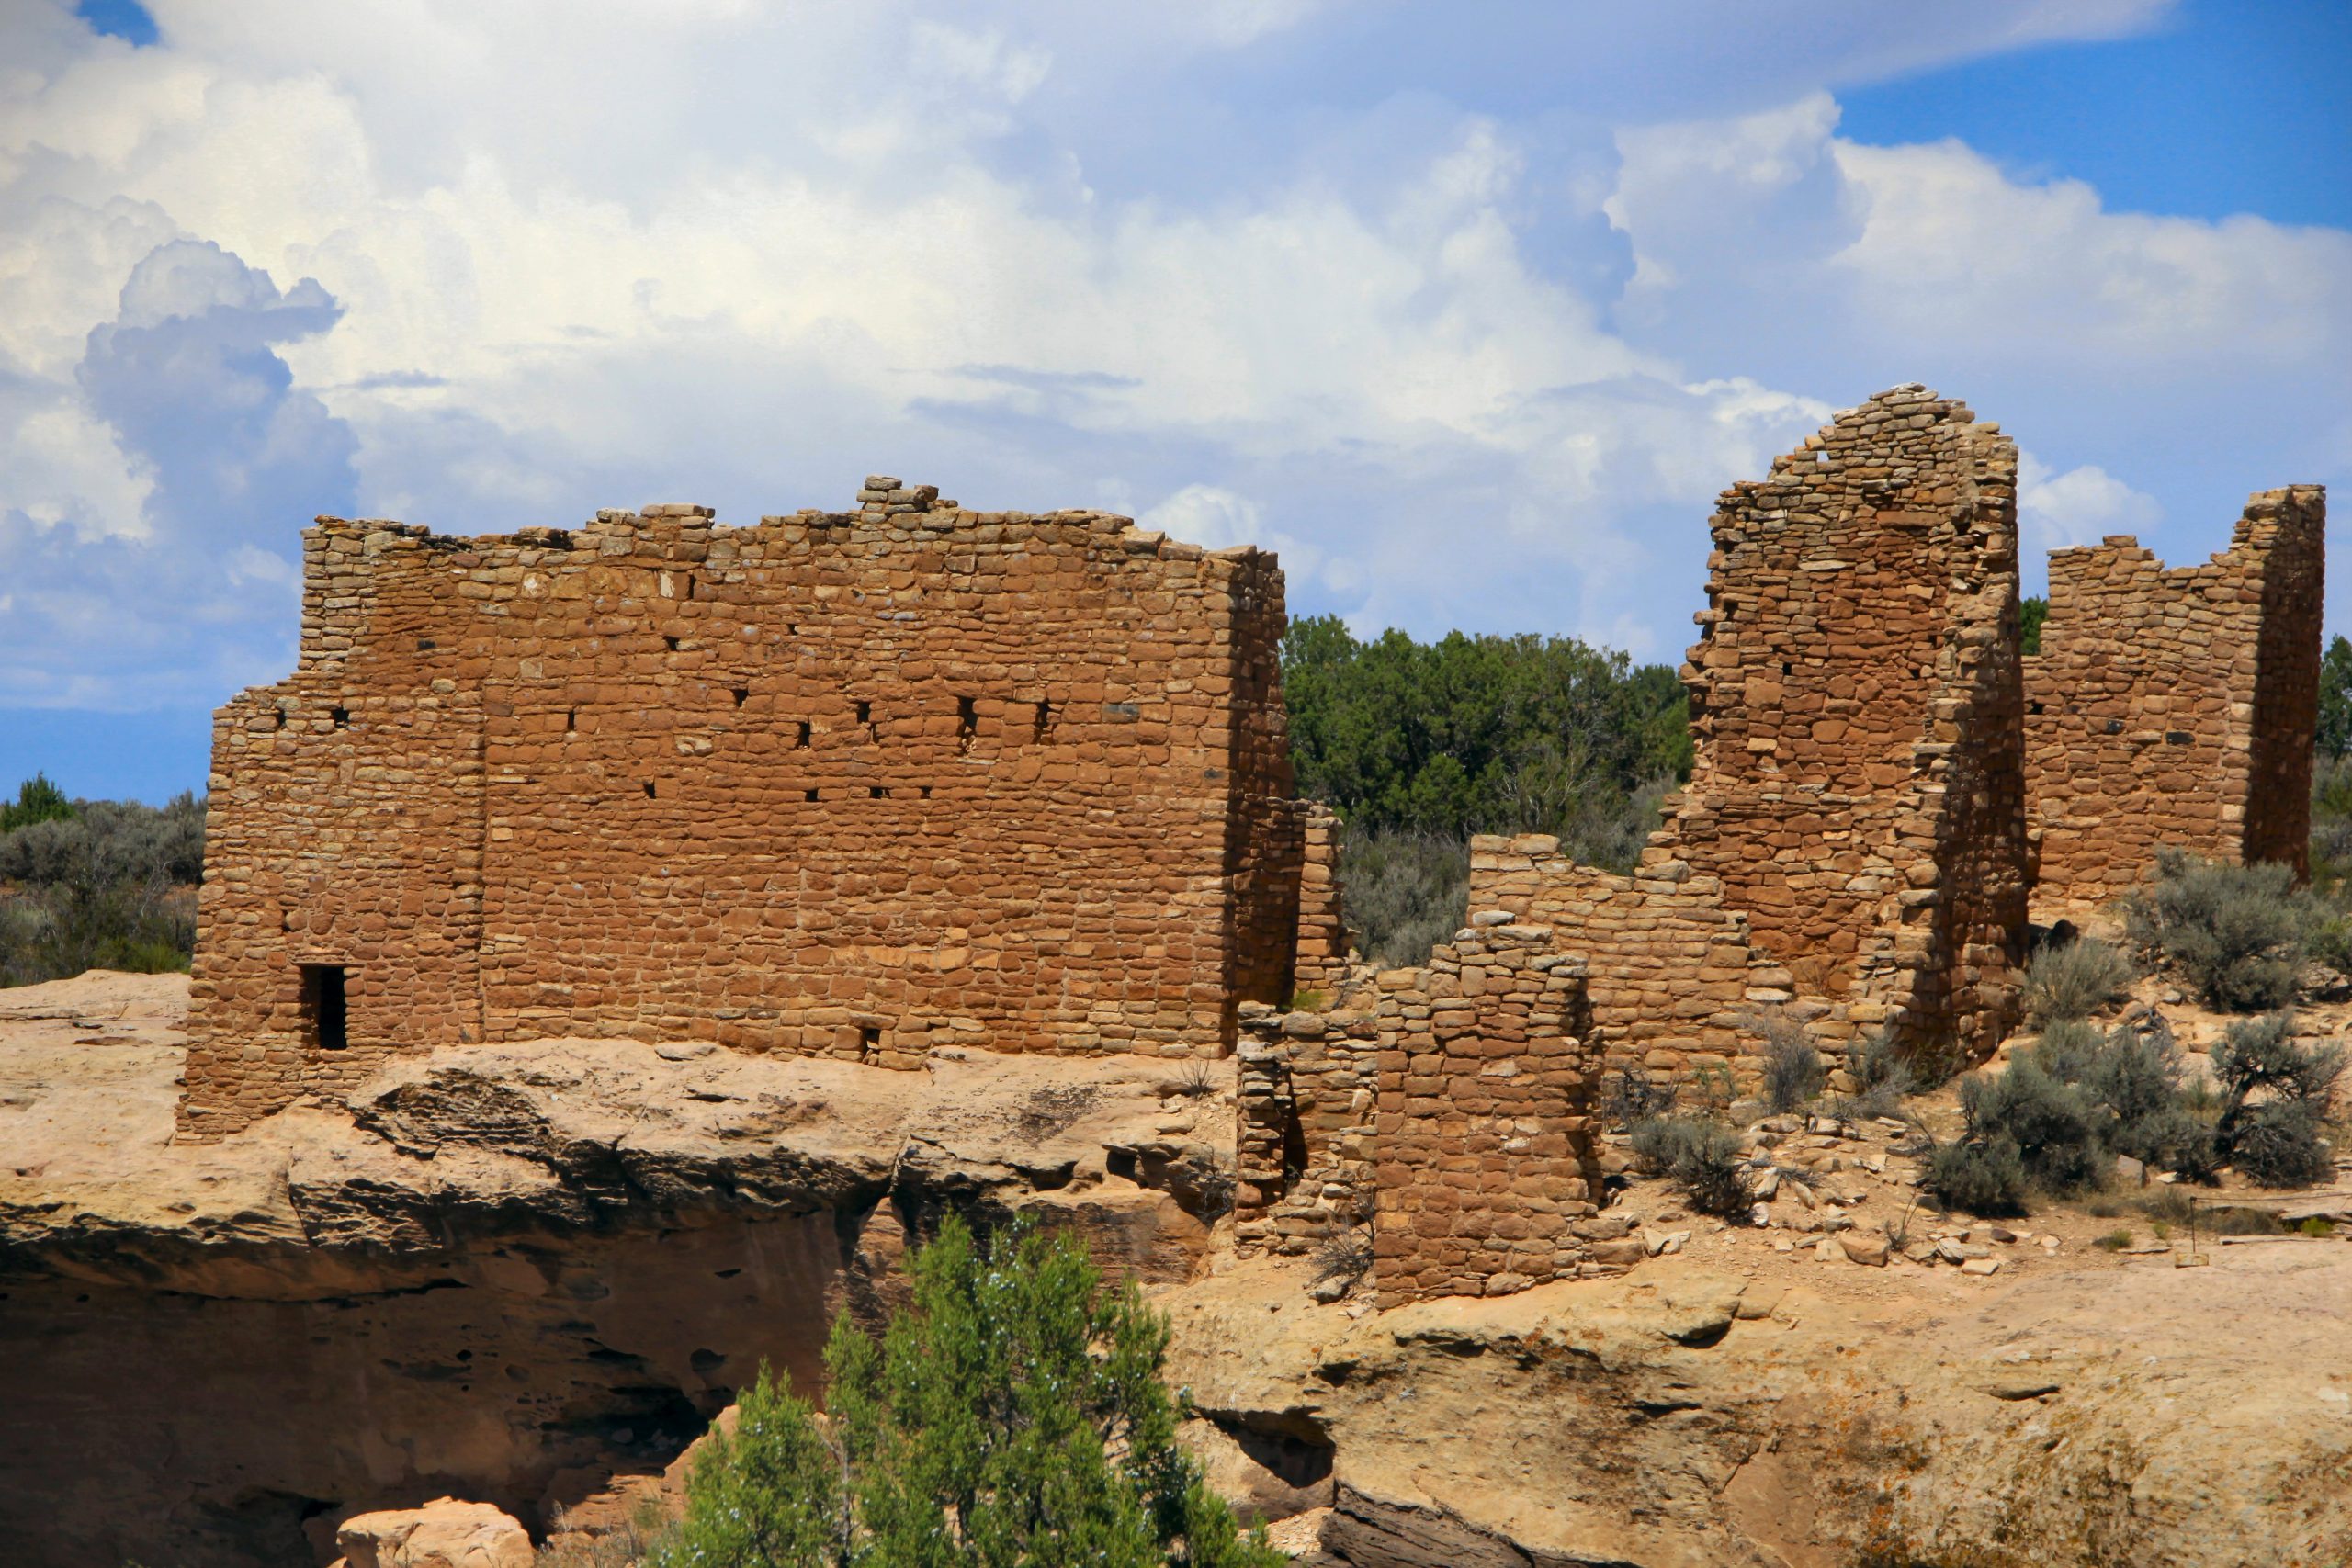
[2124, 849, 2322, 1013]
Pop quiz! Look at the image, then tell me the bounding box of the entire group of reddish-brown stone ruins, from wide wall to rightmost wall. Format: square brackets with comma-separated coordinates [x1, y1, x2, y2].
[181, 386, 2324, 1303]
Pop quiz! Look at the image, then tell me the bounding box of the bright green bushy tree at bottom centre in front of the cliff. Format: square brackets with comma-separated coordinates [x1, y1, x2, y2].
[654, 1218, 1282, 1568]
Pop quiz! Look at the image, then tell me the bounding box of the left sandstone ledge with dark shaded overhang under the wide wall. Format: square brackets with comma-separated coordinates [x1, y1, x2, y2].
[0, 976, 1230, 1568]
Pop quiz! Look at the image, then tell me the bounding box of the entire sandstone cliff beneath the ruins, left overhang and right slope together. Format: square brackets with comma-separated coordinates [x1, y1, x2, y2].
[14, 978, 2352, 1568]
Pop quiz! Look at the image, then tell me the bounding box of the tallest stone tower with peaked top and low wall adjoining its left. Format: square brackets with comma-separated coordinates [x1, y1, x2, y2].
[1470, 386, 2028, 1072]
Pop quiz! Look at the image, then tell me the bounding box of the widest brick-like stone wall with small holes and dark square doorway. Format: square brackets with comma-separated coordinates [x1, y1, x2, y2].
[181, 479, 1303, 1135]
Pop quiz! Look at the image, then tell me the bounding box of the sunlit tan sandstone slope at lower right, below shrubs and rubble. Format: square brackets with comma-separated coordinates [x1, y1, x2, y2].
[1162, 1241, 2352, 1568]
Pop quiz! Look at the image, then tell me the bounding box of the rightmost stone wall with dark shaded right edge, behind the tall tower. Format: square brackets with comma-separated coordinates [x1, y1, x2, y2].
[2025, 484, 2326, 915]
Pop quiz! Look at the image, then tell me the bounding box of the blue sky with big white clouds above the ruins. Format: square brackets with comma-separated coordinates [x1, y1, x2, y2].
[0, 0, 2352, 799]
